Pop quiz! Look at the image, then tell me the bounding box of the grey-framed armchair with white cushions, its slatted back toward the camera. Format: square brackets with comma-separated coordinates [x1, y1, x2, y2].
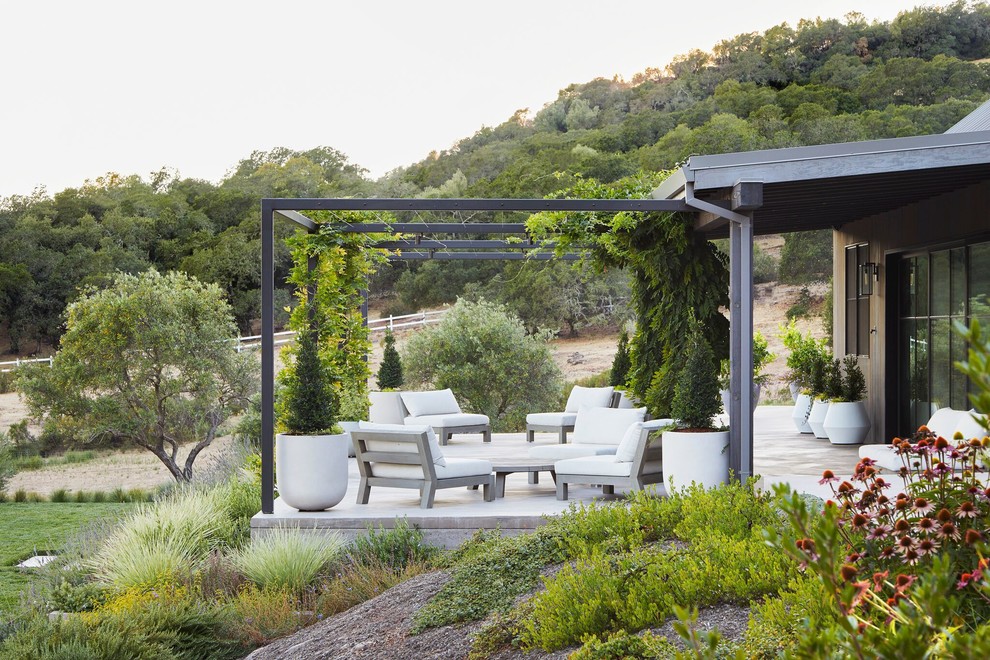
[351, 422, 495, 509]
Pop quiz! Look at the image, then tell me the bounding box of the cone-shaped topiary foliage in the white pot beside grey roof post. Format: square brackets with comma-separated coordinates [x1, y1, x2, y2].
[671, 320, 722, 429]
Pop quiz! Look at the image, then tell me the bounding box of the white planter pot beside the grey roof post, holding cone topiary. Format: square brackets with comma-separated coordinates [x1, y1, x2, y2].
[661, 431, 729, 492]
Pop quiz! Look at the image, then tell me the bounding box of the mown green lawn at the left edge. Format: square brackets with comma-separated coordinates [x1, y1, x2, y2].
[0, 503, 133, 611]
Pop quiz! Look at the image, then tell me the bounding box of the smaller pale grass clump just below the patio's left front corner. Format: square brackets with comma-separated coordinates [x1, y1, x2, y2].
[231, 527, 344, 593]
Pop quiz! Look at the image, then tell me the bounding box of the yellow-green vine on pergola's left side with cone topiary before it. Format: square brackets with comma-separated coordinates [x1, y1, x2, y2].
[277, 211, 392, 434]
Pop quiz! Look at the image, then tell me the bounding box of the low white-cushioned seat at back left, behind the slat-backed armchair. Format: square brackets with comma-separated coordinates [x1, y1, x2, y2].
[369, 389, 492, 445]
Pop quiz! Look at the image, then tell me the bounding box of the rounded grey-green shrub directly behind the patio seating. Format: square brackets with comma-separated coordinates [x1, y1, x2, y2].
[403, 300, 561, 431]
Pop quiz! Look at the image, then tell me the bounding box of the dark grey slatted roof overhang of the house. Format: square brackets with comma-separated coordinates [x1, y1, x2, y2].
[653, 131, 990, 234]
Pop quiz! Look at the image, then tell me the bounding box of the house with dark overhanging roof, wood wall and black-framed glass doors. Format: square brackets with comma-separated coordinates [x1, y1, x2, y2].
[654, 101, 990, 442]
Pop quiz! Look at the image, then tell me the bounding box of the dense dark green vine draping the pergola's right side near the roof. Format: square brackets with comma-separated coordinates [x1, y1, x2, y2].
[527, 172, 729, 417]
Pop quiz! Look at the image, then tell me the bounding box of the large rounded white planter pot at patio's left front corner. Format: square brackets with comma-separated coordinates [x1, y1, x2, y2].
[275, 433, 350, 511]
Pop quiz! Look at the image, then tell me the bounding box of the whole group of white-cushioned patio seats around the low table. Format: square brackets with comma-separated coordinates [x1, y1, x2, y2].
[351, 386, 673, 509]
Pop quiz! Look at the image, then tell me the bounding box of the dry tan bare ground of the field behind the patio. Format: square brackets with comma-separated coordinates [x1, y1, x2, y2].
[0, 274, 827, 495]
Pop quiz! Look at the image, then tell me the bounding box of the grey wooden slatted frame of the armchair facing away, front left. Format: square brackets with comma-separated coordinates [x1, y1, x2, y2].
[351, 430, 495, 509]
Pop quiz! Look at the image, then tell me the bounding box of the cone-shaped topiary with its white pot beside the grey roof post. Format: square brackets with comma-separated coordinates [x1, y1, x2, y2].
[662, 323, 729, 491]
